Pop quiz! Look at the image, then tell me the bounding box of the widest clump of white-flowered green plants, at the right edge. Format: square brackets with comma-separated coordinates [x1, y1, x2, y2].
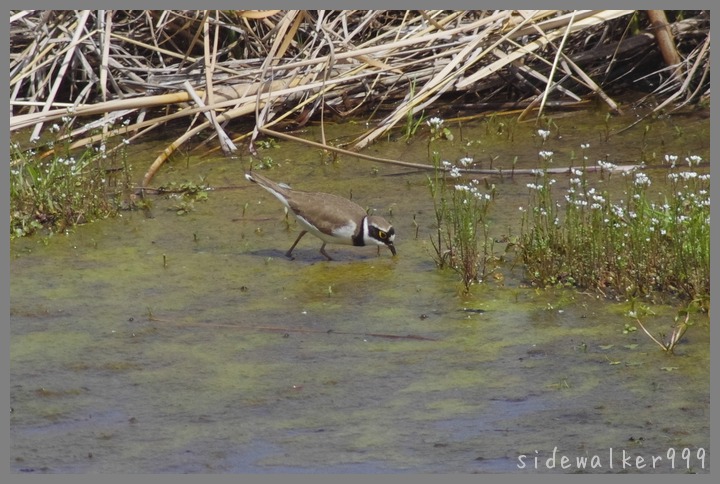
[521, 130, 710, 301]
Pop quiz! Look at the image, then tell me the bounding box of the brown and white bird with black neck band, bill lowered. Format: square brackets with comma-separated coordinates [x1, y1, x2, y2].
[245, 171, 397, 260]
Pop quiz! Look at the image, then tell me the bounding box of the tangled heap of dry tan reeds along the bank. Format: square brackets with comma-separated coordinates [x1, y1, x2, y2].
[10, 10, 710, 187]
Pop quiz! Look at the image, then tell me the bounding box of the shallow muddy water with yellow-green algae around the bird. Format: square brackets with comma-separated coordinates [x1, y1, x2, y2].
[10, 106, 710, 473]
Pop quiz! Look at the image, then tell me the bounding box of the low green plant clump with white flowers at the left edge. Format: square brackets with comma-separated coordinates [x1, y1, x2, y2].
[10, 119, 130, 238]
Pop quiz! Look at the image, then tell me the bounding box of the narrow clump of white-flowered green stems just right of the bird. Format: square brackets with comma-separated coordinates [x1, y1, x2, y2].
[428, 118, 495, 293]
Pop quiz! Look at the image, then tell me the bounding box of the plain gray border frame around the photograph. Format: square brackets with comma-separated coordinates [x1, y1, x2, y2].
[0, 0, 720, 484]
